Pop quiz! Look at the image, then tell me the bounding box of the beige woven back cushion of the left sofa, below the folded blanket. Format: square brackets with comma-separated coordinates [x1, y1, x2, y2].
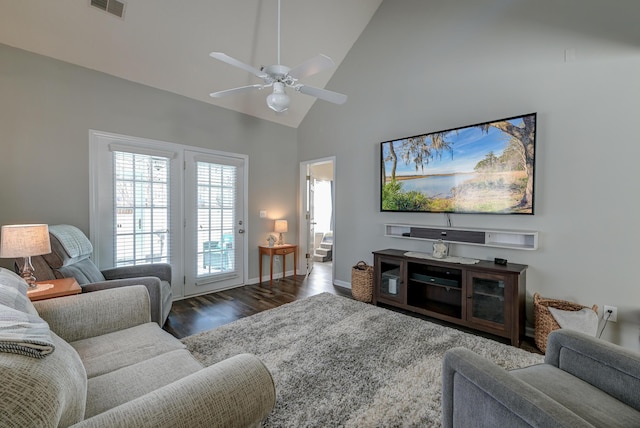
[0, 333, 87, 427]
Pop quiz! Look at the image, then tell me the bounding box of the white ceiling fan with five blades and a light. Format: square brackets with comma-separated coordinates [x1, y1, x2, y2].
[209, 0, 347, 113]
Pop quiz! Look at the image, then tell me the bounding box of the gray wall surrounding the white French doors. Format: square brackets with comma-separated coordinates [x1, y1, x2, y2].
[0, 45, 298, 286]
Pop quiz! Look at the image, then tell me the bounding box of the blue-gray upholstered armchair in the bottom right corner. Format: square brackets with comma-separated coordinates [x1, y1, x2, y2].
[442, 329, 640, 428]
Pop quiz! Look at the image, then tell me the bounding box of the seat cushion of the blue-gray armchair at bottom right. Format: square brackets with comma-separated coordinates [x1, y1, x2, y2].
[510, 364, 640, 427]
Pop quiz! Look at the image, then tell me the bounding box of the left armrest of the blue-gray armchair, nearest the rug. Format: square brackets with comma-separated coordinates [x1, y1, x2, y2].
[442, 348, 591, 427]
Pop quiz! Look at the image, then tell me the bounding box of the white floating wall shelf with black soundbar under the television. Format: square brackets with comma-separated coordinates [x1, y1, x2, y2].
[384, 224, 538, 250]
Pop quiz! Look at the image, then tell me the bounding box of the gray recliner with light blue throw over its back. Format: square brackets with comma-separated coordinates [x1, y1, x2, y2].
[31, 224, 172, 326]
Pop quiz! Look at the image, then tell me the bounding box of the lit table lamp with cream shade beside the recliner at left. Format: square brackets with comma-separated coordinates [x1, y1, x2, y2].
[0, 224, 51, 289]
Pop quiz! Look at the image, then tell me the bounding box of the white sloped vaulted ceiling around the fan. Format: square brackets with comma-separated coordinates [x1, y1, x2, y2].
[0, 0, 382, 127]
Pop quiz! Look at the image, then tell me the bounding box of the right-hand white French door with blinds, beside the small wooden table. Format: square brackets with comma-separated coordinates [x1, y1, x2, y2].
[184, 151, 245, 296]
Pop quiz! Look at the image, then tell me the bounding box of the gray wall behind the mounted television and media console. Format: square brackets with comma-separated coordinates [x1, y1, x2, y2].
[298, 0, 640, 349]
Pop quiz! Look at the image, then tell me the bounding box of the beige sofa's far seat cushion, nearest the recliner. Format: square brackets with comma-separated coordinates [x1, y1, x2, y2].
[71, 322, 185, 379]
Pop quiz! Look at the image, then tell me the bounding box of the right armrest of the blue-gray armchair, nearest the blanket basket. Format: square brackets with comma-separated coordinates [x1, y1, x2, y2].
[545, 329, 640, 410]
